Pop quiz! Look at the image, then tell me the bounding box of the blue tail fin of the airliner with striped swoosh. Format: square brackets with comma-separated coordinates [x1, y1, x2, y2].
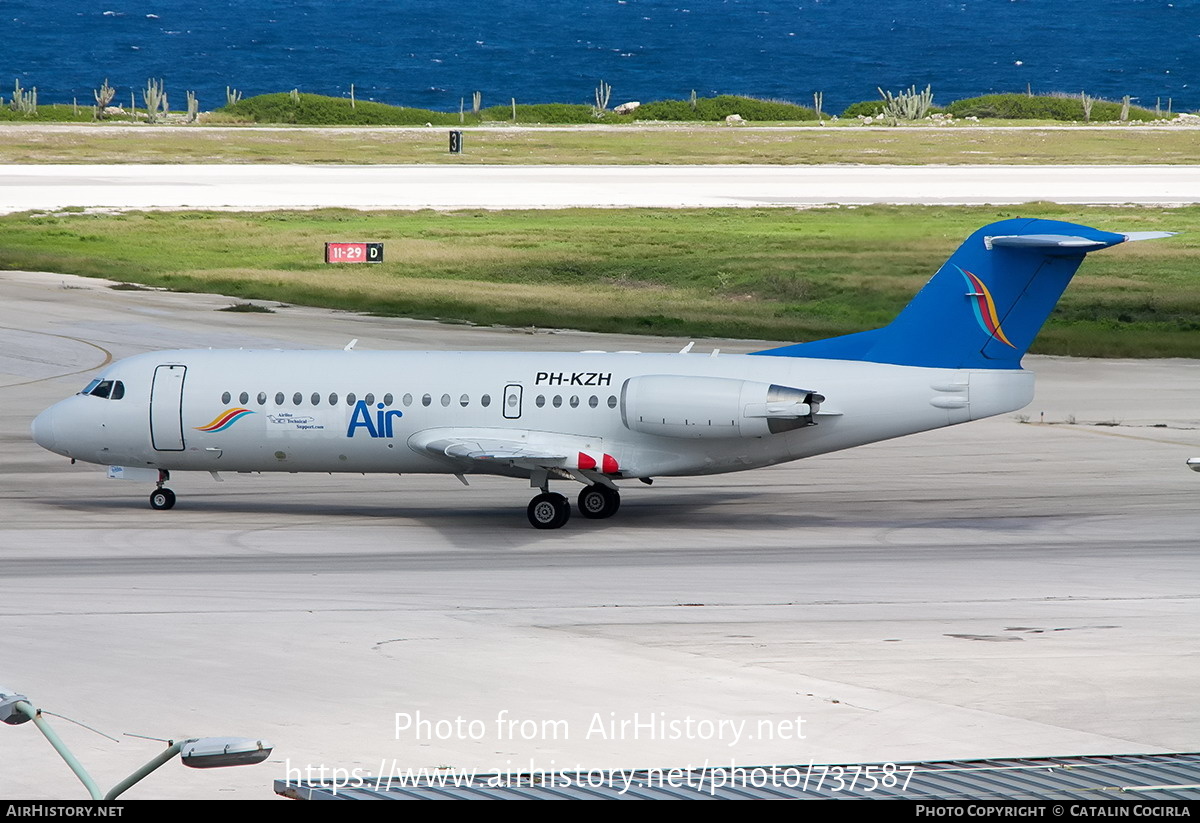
[756, 218, 1170, 368]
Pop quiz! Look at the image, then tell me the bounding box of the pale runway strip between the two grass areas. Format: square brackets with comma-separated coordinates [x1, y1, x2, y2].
[0, 166, 1200, 214]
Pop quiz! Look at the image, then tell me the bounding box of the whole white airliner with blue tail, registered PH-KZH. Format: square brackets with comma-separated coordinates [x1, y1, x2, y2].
[32, 220, 1170, 529]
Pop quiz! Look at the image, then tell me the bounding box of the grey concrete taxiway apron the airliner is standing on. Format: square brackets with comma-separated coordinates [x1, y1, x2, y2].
[0, 272, 1200, 798]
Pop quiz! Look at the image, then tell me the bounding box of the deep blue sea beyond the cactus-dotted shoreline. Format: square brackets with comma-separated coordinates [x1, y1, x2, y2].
[0, 0, 1200, 113]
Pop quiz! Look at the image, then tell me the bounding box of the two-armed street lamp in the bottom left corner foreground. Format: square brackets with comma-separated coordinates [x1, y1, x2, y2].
[0, 686, 271, 800]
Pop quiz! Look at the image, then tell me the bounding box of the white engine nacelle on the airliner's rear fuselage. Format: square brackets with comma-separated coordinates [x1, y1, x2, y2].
[620, 374, 824, 438]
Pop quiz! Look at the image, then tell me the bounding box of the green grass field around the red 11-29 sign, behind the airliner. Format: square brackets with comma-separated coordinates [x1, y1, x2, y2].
[0, 204, 1200, 358]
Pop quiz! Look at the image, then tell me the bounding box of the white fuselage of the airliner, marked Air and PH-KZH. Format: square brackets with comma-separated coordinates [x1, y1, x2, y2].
[34, 350, 1033, 479]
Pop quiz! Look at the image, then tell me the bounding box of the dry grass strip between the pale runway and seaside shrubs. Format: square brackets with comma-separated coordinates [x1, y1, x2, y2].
[0, 125, 1200, 166]
